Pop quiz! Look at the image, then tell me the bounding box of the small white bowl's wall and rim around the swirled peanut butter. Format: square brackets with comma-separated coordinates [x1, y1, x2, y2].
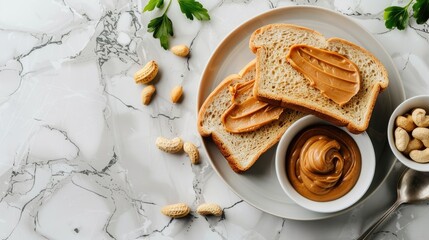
[275, 115, 375, 213]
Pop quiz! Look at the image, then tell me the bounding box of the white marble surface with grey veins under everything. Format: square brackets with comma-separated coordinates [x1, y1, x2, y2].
[0, 0, 429, 239]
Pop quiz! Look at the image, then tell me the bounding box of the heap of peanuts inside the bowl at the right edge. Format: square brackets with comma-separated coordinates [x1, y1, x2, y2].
[394, 108, 429, 163]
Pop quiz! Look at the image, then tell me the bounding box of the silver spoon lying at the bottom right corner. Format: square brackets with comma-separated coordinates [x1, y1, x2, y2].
[357, 169, 429, 240]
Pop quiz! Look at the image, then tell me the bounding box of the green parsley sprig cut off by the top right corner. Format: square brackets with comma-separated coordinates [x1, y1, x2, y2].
[384, 0, 429, 30]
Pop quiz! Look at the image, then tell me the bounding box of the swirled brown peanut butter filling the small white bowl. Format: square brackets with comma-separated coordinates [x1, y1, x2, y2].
[286, 125, 361, 202]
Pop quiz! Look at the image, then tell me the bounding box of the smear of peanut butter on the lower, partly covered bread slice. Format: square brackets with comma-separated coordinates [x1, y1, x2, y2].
[221, 80, 283, 133]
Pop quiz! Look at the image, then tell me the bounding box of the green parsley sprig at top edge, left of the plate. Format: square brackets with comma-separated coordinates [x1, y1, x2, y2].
[143, 0, 210, 49]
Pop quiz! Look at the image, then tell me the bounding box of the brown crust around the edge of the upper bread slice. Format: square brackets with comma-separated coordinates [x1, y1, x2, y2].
[249, 24, 388, 134]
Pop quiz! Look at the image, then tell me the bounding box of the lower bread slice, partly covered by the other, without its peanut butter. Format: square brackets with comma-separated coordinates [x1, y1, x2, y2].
[197, 60, 304, 173]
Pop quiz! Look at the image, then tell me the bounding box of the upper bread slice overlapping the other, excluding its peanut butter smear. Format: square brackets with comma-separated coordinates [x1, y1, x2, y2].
[249, 24, 389, 133]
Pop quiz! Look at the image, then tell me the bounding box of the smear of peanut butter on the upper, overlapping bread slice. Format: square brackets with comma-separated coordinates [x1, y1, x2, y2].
[286, 44, 361, 106]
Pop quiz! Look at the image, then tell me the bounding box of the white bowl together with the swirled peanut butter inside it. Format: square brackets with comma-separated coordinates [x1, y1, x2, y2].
[275, 115, 375, 213]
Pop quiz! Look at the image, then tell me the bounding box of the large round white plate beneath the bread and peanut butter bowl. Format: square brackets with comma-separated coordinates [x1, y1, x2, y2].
[197, 6, 405, 220]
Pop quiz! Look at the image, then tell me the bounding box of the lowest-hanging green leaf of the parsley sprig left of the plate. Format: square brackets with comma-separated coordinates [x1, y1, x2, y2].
[147, 12, 174, 50]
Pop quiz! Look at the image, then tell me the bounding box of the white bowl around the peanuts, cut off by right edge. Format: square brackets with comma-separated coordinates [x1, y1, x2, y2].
[387, 95, 429, 172]
